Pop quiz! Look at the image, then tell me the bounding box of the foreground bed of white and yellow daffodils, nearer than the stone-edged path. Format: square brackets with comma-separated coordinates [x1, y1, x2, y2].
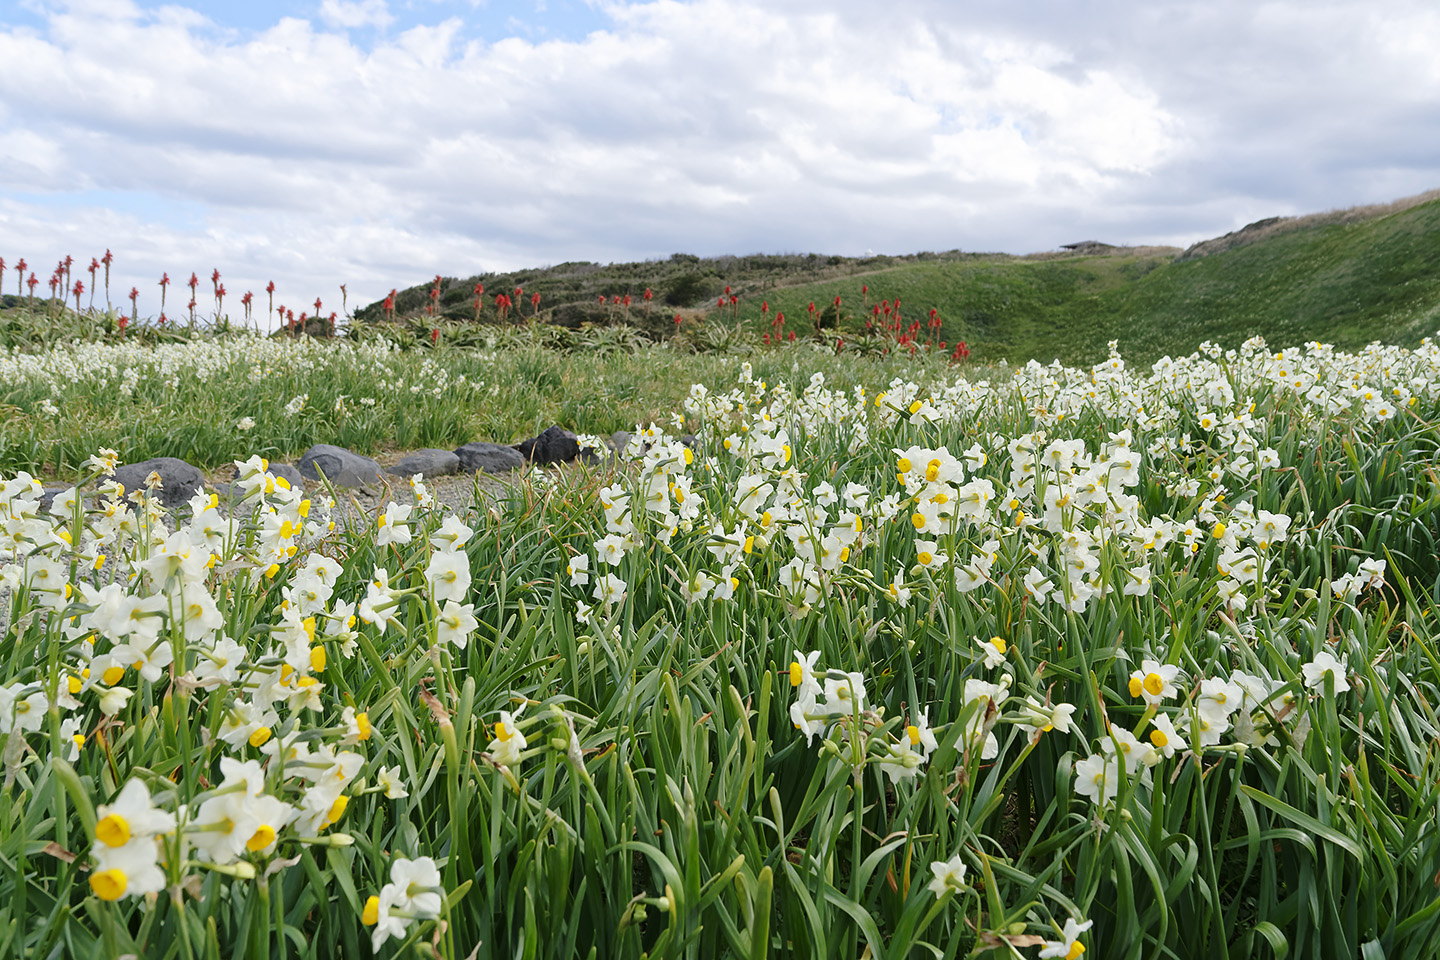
[0, 333, 1440, 960]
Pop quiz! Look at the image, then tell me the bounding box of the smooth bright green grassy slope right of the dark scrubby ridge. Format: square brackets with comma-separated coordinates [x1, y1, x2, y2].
[740, 192, 1440, 363]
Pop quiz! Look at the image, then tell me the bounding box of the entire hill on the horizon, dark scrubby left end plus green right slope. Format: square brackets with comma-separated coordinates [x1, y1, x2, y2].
[360, 194, 1440, 363]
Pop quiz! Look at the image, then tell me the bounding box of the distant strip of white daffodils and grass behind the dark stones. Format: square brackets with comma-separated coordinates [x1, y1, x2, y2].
[0, 327, 967, 476]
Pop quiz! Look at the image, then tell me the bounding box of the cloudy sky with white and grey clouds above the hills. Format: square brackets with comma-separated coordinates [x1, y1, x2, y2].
[0, 0, 1440, 315]
